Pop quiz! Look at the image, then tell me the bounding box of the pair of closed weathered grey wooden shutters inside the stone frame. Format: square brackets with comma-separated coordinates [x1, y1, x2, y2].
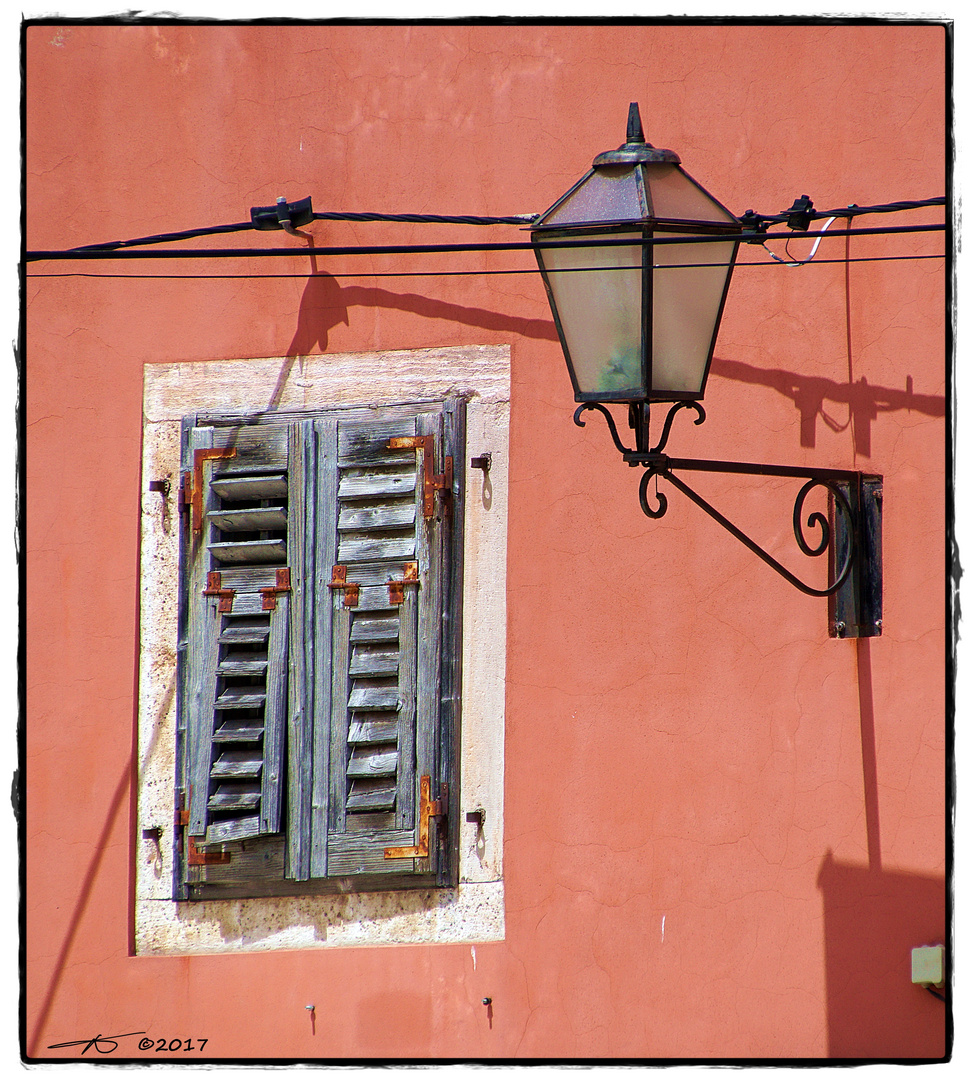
[177, 400, 464, 897]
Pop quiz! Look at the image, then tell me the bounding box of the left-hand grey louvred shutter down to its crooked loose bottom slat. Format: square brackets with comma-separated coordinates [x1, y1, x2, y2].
[183, 426, 294, 845]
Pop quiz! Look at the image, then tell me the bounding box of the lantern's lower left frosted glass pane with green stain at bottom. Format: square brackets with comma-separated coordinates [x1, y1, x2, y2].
[541, 232, 645, 401]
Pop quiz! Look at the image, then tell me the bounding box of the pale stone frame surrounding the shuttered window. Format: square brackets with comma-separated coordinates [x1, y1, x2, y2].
[135, 346, 510, 955]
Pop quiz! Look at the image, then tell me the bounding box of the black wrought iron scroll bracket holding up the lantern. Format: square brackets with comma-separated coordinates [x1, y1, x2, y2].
[573, 402, 882, 637]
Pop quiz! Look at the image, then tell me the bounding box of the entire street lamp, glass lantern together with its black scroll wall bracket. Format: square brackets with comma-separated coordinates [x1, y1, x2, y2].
[530, 103, 882, 637]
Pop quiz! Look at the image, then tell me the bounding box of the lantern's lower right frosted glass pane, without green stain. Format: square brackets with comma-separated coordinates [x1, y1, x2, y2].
[651, 232, 735, 396]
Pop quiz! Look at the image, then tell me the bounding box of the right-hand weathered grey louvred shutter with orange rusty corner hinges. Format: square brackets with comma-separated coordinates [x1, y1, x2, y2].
[310, 410, 451, 877]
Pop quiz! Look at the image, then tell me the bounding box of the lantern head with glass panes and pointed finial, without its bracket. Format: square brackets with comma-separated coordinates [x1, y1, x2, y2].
[531, 104, 742, 416]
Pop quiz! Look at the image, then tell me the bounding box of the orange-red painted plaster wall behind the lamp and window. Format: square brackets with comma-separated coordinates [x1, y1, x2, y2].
[25, 24, 946, 1058]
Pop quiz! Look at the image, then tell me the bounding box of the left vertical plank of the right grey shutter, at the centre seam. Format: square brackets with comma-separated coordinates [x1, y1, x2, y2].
[315, 416, 347, 877]
